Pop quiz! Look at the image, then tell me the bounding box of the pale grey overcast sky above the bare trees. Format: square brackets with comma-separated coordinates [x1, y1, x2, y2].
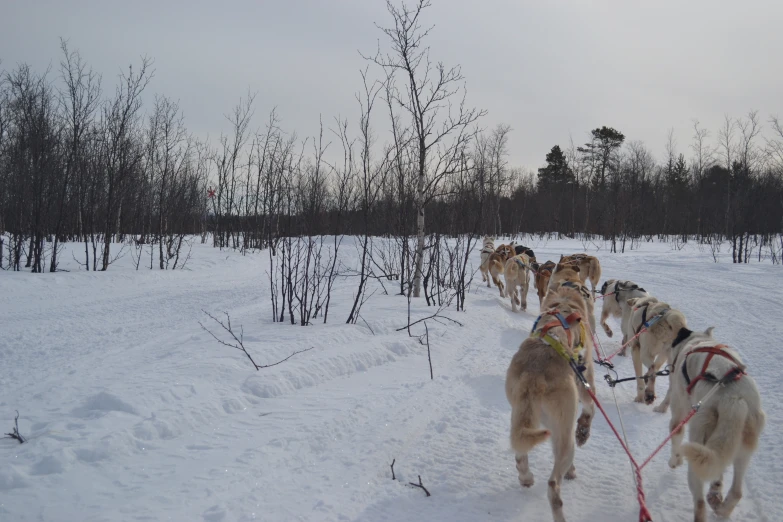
[0, 0, 783, 168]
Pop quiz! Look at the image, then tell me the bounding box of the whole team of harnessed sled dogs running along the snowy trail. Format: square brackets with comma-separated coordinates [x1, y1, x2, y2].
[480, 237, 765, 522]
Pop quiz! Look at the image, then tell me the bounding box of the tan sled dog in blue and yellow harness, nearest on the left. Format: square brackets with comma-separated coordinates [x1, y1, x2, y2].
[506, 286, 595, 522]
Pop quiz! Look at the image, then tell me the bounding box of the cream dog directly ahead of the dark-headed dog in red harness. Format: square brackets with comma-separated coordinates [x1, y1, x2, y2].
[628, 298, 688, 406]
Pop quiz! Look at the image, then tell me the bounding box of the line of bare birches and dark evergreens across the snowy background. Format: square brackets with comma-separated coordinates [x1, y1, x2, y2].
[0, 0, 783, 284]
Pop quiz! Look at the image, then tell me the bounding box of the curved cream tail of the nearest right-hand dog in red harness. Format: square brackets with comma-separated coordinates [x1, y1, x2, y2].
[682, 398, 748, 480]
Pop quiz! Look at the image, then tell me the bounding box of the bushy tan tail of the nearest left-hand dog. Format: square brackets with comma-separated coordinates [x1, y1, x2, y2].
[511, 373, 550, 453]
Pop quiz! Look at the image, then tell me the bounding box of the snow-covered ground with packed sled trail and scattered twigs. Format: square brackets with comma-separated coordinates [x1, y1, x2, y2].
[0, 236, 783, 522]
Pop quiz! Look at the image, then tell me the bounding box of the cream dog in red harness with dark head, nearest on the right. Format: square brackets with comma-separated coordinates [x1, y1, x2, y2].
[669, 328, 766, 522]
